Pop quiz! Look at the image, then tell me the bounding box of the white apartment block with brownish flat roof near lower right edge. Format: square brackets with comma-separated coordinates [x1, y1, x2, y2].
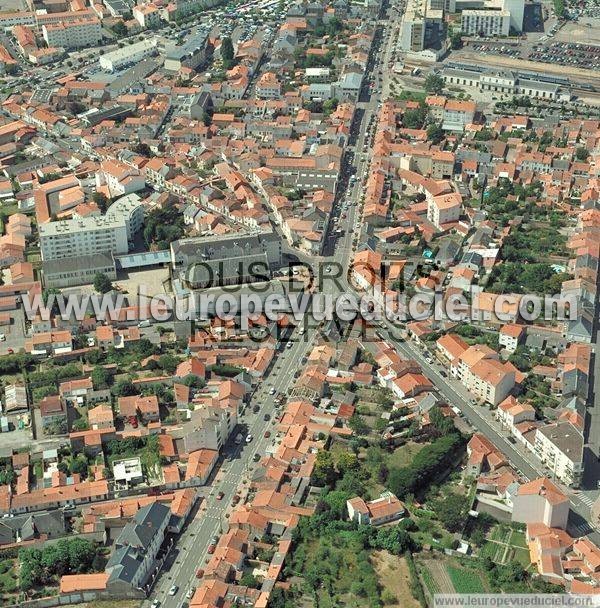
[533, 421, 583, 487]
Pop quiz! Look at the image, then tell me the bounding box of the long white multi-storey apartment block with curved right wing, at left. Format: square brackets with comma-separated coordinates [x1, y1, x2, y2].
[39, 196, 144, 262]
